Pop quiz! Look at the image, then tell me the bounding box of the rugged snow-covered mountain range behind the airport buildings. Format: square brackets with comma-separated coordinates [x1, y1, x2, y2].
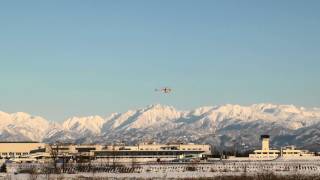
[0, 104, 320, 150]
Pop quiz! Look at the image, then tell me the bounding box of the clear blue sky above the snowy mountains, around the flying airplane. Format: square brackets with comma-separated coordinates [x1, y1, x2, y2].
[0, 0, 320, 121]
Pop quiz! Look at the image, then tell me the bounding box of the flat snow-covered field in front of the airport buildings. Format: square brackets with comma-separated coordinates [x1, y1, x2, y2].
[0, 161, 320, 180]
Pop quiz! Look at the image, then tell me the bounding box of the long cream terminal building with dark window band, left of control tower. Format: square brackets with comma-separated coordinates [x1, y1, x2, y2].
[23, 143, 211, 162]
